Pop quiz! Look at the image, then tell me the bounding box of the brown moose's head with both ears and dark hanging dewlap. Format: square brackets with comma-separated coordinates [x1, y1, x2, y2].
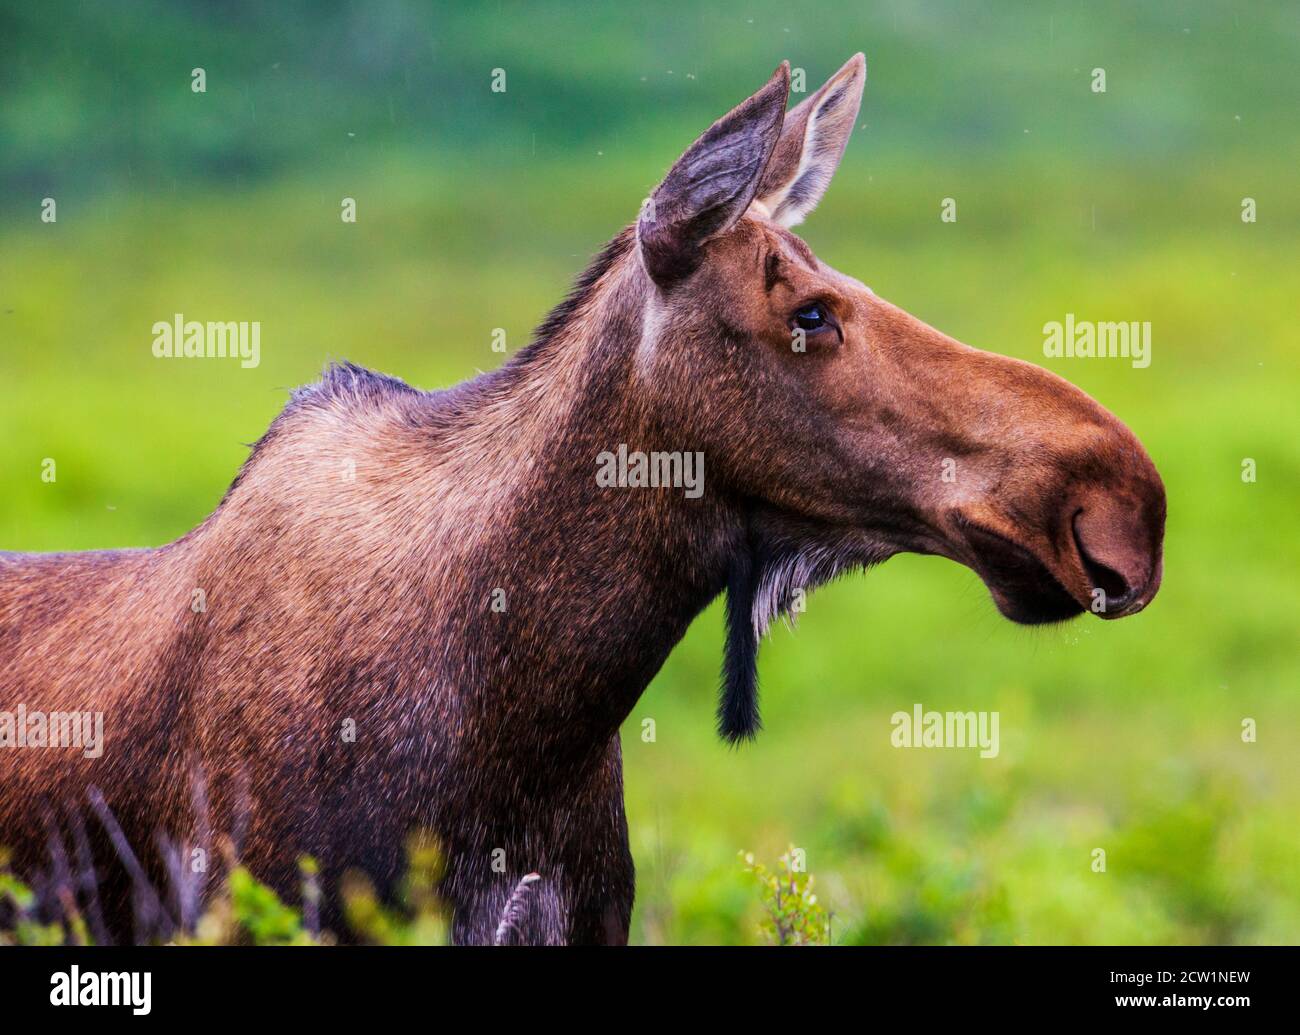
[636, 53, 1165, 740]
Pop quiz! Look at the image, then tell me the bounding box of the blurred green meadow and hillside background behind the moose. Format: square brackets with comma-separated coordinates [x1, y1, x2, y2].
[0, 0, 1300, 943]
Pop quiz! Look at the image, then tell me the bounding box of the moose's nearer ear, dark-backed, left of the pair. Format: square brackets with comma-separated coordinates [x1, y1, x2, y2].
[637, 61, 790, 287]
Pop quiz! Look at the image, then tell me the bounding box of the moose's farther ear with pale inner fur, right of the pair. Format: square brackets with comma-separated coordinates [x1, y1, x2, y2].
[758, 53, 867, 226]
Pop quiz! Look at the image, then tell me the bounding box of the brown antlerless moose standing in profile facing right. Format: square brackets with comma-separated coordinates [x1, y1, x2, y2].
[0, 53, 1165, 944]
